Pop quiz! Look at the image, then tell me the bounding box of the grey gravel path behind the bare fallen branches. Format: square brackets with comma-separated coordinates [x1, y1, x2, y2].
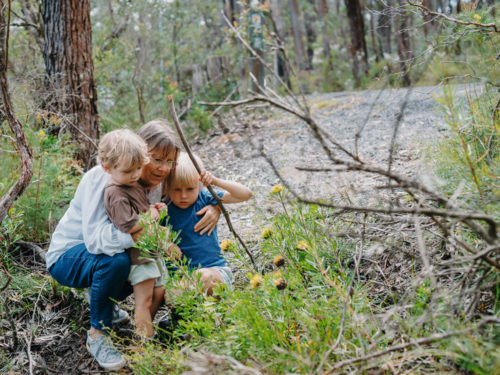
[193, 86, 464, 240]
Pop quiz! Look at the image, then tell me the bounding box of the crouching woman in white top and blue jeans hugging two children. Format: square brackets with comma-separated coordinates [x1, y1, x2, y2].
[46, 120, 220, 370]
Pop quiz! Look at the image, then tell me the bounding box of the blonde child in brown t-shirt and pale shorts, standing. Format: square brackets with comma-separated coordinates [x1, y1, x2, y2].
[98, 129, 167, 340]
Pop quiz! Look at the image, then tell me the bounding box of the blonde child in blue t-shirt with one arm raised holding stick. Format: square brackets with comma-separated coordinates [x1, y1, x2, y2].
[158, 152, 252, 295]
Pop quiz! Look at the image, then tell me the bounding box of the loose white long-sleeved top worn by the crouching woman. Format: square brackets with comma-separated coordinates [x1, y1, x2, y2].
[46, 165, 134, 268]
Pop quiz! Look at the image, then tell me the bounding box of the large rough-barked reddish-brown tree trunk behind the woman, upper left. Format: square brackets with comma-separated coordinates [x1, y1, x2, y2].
[42, 0, 99, 169]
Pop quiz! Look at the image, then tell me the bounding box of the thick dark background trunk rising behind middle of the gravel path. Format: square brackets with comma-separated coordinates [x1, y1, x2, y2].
[344, 0, 368, 84]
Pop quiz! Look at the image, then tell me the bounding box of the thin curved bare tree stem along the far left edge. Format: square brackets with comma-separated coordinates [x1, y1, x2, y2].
[0, 0, 33, 224]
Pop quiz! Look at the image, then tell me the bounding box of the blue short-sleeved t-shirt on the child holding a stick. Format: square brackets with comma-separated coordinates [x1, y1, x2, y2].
[167, 190, 226, 268]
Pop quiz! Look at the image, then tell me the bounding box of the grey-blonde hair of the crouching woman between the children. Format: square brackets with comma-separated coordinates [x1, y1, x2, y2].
[137, 119, 181, 197]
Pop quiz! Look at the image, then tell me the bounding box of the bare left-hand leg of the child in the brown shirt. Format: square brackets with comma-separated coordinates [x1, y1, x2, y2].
[134, 279, 155, 337]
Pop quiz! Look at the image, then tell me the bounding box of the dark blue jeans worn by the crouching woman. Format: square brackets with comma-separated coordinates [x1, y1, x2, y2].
[49, 244, 134, 331]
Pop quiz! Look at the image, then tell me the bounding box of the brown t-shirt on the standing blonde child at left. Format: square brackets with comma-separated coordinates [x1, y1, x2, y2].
[104, 182, 151, 265]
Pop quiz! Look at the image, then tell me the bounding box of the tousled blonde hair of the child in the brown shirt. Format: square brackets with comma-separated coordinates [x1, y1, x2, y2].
[98, 129, 149, 170]
